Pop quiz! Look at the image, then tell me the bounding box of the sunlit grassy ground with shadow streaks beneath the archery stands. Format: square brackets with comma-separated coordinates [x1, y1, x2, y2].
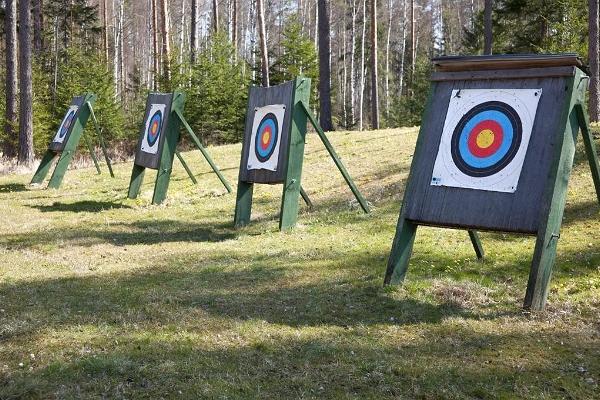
[0, 129, 600, 400]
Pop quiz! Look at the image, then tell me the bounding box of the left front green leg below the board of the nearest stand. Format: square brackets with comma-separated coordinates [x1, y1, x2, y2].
[383, 215, 418, 285]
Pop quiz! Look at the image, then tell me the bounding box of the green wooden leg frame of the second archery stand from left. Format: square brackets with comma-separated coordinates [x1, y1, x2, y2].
[127, 92, 232, 204]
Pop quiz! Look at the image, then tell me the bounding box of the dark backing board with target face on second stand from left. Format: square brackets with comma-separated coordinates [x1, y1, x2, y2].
[135, 93, 173, 169]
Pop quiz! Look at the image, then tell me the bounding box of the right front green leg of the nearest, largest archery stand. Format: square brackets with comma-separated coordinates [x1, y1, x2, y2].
[523, 70, 585, 310]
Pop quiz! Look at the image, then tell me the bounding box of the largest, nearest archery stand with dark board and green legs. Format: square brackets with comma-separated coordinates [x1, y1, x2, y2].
[385, 54, 600, 310]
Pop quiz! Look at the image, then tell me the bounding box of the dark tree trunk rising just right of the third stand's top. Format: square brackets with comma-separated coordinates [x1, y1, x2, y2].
[317, 0, 333, 132]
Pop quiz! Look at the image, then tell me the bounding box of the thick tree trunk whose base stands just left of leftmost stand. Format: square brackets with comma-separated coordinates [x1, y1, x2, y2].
[19, 0, 33, 167]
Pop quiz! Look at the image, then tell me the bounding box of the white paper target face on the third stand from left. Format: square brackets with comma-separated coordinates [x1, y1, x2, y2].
[248, 104, 285, 171]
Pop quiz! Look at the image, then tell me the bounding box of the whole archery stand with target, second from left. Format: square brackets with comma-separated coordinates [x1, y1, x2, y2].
[128, 92, 232, 204]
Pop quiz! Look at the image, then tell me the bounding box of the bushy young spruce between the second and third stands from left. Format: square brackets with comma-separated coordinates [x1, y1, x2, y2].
[180, 32, 249, 143]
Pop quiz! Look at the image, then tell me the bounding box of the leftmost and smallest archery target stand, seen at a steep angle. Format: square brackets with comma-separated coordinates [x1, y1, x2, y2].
[31, 93, 115, 189]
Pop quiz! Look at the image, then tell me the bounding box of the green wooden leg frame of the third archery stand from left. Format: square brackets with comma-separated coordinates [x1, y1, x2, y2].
[234, 77, 370, 230]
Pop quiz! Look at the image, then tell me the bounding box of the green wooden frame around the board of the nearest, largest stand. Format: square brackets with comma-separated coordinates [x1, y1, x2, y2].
[384, 58, 600, 310]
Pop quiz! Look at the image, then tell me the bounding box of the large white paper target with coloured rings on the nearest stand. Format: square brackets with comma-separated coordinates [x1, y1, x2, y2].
[431, 89, 542, 193]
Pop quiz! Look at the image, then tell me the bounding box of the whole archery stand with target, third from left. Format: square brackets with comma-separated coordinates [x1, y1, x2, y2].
[234, 77, 370, 230]
